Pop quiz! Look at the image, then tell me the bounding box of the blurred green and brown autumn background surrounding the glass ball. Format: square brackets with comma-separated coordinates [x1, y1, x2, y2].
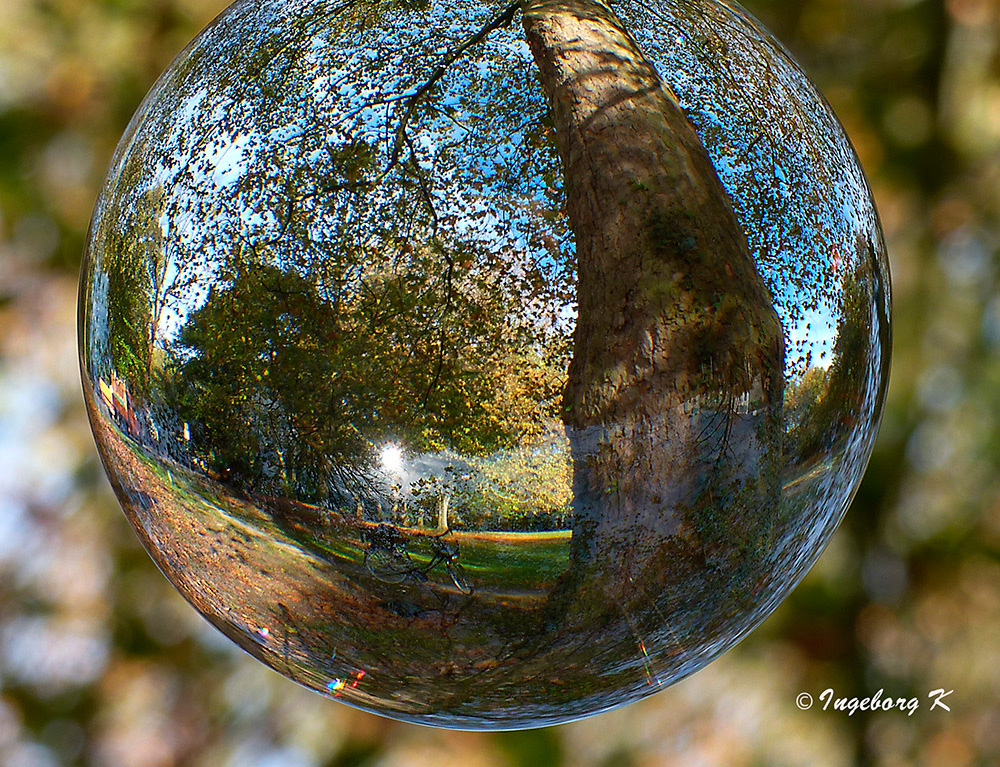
[0, 0, 1000, 767]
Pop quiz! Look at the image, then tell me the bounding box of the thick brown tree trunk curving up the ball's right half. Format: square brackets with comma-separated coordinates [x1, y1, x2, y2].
[523, 0, 784, 605]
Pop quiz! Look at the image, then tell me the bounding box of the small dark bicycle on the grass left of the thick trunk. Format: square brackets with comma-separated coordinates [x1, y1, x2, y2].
[362, 523, 474, 595]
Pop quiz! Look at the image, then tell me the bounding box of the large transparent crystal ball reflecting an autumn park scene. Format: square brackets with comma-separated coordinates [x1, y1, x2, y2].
[80, 0, 890, 729]
